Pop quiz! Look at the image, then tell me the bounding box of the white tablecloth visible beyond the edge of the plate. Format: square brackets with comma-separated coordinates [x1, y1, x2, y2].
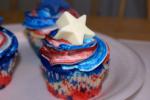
[2, 24, 150, 100]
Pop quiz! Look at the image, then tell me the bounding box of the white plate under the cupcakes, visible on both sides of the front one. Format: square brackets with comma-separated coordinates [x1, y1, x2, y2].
[0, 25, 145, 100]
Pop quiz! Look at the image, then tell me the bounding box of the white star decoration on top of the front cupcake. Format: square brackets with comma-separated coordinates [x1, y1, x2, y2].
[54, 12, 95, 45]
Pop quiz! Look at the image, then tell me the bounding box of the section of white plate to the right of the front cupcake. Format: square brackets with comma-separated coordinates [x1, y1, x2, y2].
[97, 35, 145, 100]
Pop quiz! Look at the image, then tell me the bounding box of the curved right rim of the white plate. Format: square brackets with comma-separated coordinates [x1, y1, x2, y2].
[94, 33, 146, 100]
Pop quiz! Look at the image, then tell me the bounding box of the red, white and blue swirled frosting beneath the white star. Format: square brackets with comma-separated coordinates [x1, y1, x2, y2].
[40, 29, 108, 72]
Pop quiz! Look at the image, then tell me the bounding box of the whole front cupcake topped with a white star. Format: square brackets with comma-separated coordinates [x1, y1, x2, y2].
[40, 12, 110, 100]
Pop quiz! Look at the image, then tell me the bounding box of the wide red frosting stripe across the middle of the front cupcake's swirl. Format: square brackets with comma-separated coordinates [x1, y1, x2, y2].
[40, 46, 96, 64]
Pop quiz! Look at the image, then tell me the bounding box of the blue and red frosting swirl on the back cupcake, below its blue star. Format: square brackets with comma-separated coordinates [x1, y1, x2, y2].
[23, 6, 78, 29]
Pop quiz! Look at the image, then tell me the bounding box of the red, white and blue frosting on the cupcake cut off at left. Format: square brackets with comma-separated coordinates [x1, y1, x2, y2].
[0, 27, 18, 67]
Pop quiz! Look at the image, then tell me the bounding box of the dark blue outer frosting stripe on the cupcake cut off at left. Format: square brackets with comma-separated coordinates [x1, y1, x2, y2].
[0, 27, 18, 59]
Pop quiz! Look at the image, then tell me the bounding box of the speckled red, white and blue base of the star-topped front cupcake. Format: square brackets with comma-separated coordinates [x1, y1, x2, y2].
[41, 53, 108, 100]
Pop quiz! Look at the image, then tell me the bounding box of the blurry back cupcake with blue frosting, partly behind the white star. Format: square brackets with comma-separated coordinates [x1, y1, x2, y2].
[24, 0, 78, 54]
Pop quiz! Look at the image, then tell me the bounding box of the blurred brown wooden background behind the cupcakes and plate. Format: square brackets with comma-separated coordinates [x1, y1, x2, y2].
[0, 0, 150, 40]
